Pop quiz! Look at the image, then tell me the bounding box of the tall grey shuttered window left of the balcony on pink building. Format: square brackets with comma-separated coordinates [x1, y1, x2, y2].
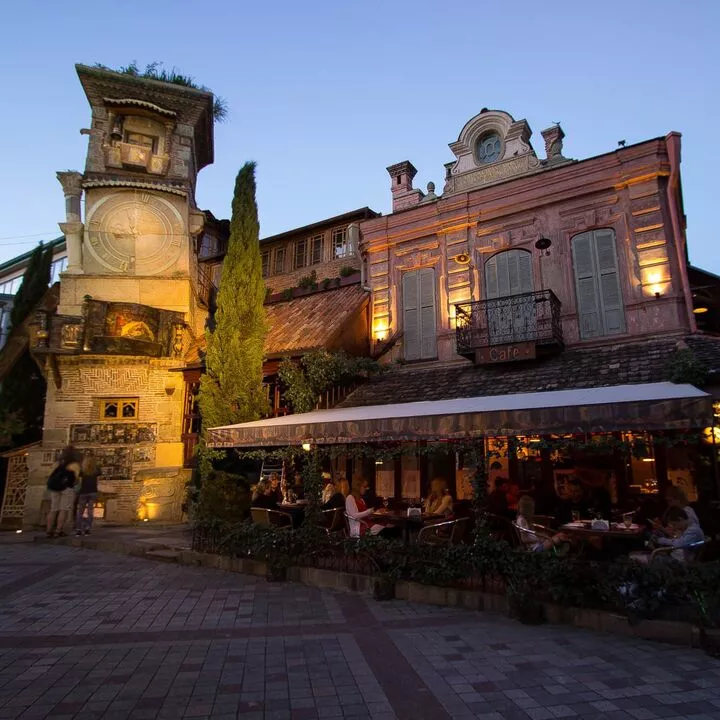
[402, 268, 437, 360]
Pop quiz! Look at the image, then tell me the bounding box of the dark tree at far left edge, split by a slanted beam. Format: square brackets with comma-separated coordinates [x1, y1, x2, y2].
[0, 245, 53, 445]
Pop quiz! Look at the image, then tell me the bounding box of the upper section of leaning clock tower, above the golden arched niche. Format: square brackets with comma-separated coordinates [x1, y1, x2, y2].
[58, 65, 213, 331]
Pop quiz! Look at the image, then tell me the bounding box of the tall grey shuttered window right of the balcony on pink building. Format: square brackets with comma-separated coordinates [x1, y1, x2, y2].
[572, 228, 625, 338]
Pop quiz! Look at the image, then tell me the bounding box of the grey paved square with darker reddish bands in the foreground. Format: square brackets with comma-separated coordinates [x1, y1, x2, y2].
[0, 543, 720, 720]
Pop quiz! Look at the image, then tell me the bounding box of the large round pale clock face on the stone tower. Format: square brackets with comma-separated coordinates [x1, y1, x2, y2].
[85, 191, 184, 275]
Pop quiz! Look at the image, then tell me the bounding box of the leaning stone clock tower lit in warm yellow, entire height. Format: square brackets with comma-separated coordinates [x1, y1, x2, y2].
[25, 65, 219, 525]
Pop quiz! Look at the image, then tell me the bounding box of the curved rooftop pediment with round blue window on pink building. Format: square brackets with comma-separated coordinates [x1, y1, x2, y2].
[443, 110, 540, 195]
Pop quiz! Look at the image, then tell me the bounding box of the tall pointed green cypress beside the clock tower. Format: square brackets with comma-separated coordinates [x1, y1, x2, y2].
[198, 162, 268, 478]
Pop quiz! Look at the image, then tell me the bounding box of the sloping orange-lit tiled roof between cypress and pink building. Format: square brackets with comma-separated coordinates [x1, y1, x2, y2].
[265, 285, 369, 357]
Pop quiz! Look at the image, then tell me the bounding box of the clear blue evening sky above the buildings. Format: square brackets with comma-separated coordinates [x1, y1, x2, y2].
[0, 0, 720, 273]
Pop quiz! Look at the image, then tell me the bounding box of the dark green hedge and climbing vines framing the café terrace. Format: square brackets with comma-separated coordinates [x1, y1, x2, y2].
[193, 433, 720, 640]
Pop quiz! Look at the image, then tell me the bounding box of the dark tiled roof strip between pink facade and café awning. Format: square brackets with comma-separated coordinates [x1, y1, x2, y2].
[341, 335, 720, 407]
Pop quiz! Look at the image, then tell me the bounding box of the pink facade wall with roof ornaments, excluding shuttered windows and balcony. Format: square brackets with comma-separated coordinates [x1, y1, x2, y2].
[360, 111, 694, 361]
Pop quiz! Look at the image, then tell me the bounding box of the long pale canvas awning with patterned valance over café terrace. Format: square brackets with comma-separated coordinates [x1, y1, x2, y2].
[208, 382, 713, 447]
